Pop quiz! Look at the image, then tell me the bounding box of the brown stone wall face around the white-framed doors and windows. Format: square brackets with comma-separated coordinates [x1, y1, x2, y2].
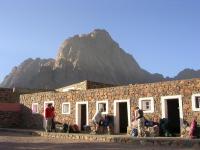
[20, 79, 200, 135]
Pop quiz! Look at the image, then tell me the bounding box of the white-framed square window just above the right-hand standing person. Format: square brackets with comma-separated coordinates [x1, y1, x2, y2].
[139, 97, 154, 113]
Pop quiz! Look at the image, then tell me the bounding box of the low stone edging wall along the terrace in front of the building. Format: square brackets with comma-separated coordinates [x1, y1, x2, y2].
[33, 131, 200, 149]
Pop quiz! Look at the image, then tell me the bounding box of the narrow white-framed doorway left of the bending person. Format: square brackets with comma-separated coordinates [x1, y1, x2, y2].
[76, 102, 88, 130]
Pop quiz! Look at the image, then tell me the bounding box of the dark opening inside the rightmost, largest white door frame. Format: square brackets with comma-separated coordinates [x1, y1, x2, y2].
[167, 99, 180, 135]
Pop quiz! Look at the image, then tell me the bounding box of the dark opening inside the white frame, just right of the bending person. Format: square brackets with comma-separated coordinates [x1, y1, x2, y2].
[119, 102, 128, 133]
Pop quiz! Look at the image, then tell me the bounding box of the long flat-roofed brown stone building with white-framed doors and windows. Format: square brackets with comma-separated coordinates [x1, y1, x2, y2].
[20, 79, 200, 136]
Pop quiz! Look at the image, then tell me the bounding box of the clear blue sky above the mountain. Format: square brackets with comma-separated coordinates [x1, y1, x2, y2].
[0, 0, 200, 81]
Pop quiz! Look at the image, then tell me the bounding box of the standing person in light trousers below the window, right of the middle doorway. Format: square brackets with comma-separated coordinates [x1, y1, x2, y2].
[135, 107, 145, 137]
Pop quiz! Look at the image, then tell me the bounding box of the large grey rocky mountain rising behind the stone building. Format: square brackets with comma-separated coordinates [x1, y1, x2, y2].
[0, 29, 198, 88]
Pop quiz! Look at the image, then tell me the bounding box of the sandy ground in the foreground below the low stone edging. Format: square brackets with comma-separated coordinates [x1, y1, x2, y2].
[0, 132, 199, 150]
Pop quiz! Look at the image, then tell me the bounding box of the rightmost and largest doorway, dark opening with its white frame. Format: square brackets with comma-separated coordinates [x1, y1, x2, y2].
[161, 95, 183, 136]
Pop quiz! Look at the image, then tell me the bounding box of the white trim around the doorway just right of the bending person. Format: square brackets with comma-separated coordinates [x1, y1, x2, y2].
[114, 99, 131, 133]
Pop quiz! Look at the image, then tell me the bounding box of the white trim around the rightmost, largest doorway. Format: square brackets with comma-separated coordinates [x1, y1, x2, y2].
[161, 95, 183, 129]
